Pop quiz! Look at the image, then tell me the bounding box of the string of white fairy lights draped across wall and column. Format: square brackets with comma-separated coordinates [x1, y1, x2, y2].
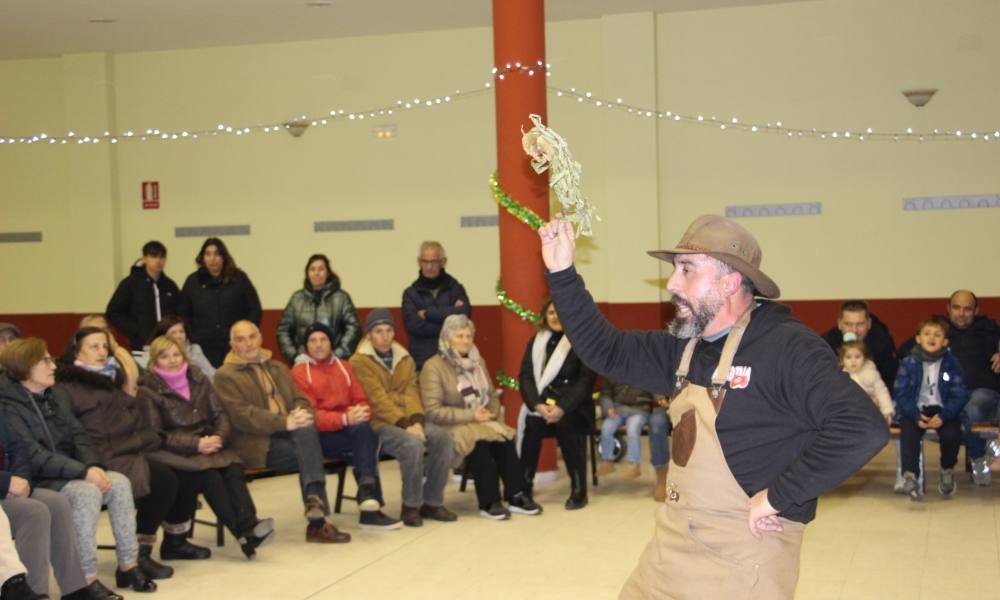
[0, 60, 1000, 146]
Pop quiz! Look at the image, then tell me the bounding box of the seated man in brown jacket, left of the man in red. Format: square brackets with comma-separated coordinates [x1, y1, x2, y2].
[213, 321, 351, 544]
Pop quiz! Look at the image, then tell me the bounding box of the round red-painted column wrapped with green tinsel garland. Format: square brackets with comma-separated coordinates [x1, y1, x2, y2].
[493, 0, 555, 471]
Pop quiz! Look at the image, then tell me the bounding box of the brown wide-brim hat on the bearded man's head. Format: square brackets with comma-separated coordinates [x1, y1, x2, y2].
[647, 215, 781, 298]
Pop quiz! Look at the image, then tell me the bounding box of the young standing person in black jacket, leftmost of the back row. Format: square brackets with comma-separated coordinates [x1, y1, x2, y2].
[104, 240, 181, 350]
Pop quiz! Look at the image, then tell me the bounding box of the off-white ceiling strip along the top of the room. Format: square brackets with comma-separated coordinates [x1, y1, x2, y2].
[0, 0, 802, 59]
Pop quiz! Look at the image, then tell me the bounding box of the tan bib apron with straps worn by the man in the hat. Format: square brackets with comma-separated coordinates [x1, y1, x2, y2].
[619, 311, 805, 600]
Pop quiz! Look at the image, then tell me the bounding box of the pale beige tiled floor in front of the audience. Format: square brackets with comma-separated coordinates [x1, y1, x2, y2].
[88, 444, 1000, 600]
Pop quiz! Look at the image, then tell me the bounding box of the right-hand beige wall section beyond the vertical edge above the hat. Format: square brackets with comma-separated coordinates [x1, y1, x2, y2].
[657, 0, 1000, 299]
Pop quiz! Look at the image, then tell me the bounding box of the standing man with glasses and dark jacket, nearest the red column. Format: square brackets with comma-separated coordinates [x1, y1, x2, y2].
[403, 241, 472, 371]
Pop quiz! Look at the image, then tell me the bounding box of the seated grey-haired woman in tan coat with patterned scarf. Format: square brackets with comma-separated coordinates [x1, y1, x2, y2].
[420, 315, 542, 520]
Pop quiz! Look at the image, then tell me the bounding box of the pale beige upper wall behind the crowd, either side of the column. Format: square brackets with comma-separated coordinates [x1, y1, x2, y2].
[0, 0, 1000, 313]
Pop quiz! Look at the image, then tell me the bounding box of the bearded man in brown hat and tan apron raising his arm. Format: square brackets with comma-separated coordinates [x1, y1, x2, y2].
[539, 215, 888, 600]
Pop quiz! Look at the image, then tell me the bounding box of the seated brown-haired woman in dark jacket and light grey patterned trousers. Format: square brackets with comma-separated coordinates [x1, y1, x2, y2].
[0, 338, 156, 598]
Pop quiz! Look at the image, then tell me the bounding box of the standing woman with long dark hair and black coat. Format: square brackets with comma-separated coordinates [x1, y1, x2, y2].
[180, 237, 261, 367]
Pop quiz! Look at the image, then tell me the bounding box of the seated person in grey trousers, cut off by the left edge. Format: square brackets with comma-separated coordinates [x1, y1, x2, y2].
[0, 406, 110, 600]
